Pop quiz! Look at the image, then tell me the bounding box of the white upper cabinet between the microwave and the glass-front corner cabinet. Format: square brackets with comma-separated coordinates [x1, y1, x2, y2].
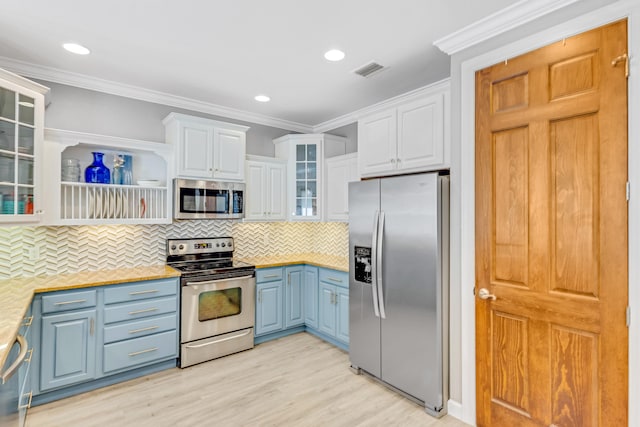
[245, 156, 287, 221]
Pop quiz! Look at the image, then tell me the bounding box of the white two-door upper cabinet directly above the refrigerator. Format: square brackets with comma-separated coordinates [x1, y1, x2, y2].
[358, 85, 449, 177]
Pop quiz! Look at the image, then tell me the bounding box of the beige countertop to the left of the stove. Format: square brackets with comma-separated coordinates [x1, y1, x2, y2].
[0, 265, 180, 370]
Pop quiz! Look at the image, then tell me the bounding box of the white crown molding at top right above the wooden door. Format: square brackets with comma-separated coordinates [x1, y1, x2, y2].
[433, 0, 578, 55]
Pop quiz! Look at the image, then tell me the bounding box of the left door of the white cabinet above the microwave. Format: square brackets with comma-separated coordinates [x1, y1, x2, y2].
[178, 123, 213, 178]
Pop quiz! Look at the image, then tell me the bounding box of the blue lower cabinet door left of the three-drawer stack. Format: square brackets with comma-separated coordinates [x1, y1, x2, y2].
[40, 309, 96, 391]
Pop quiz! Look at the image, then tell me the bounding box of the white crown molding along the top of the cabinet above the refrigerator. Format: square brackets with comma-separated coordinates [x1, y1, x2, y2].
[313, 78, 451, 133]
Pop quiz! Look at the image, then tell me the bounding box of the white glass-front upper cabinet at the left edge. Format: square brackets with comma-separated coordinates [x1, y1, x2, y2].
[0, 69, 48, 223]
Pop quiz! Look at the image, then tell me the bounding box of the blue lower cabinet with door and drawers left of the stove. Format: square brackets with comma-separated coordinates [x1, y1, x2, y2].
[31, 278, 179, 404]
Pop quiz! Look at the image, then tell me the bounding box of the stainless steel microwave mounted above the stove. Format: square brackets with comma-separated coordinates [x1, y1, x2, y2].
[173, 178, 245, 219]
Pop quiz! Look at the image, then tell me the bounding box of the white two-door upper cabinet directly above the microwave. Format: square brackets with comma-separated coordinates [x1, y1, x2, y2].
[163, 113, 249, 181]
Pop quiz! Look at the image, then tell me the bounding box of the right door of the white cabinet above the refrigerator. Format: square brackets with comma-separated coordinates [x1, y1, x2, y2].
[397, 94, 444, 170]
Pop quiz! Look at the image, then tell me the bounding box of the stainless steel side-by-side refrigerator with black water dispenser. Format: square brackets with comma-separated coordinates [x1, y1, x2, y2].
[349, 173, 449, 417]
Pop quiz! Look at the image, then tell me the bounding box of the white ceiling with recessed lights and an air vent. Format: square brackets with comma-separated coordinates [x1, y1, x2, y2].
[0, 0, 514, 130]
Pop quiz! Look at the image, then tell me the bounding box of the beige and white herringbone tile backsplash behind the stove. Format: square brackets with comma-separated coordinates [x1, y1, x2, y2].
[0, 221, 349, 279]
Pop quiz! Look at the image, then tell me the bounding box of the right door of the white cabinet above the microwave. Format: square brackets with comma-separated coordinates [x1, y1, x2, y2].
[213, 128, 246, 181]
